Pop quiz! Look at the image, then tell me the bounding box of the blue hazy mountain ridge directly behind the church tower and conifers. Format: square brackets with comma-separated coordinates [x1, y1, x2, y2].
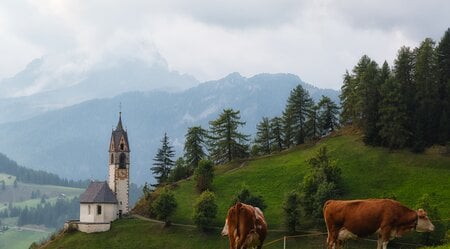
[0, 73, 338, 183]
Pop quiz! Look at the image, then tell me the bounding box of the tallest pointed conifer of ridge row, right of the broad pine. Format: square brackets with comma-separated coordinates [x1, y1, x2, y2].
[284, 85, 314, 145]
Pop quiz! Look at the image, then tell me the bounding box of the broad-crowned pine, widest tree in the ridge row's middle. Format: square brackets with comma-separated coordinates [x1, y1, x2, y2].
[209, 109, 249, 163]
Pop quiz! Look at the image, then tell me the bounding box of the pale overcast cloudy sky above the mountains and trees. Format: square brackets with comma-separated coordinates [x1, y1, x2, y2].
[0, 0, 450, 89]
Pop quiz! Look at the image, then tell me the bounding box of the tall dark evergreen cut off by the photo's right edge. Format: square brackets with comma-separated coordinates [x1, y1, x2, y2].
[436, 28, 450, 144]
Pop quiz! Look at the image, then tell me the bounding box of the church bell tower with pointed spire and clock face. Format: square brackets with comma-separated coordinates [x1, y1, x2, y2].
[108, 112, 130, 217]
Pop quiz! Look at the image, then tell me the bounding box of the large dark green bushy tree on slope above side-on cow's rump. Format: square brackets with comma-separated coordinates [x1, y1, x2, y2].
[299, 147, 342, 219]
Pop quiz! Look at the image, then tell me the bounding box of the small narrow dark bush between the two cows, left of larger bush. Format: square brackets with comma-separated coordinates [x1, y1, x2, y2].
[283, 191, 301, 234]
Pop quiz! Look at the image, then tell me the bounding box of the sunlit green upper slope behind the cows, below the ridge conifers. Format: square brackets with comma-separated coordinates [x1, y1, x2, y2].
[174, 135, 450, 228]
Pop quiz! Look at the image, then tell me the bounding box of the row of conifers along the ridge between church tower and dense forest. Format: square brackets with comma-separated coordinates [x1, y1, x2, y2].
[150, 85, 339, 186]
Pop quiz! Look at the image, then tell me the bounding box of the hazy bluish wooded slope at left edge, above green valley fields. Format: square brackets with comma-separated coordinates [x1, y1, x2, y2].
[0, 153, 89, 188]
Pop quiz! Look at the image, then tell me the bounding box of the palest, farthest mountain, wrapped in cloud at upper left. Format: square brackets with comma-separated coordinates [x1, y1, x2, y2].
[0, 58, 199, 123]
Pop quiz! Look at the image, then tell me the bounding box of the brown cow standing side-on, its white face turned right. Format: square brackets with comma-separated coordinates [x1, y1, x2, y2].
[323, 199, 434, 249]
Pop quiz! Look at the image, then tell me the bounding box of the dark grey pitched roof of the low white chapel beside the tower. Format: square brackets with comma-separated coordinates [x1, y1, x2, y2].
[80, 181, 117, 203]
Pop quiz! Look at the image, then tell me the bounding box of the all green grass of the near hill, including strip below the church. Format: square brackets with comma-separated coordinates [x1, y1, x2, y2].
[40, 135, 450, 248]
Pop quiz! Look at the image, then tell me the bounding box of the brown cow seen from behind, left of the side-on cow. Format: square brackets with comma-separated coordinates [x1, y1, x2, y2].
[222, 202, 267, 249]
